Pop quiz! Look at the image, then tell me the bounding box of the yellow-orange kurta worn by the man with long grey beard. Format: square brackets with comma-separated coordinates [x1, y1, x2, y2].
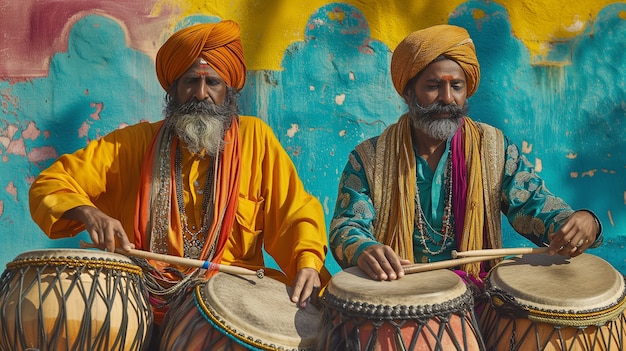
[29, 116, 327, 283]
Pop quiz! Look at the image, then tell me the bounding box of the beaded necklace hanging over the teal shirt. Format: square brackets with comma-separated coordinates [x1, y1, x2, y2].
[414, 152, 453, 256]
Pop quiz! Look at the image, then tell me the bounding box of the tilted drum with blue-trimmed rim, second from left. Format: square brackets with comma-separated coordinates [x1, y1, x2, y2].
[160, 272, 321, 351]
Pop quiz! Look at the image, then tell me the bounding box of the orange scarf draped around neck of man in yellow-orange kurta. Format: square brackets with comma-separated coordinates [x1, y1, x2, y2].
[135, 117, 241, 279]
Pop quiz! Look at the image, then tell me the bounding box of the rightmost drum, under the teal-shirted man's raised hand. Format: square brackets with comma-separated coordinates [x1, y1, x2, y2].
[480, 254, 626, 351]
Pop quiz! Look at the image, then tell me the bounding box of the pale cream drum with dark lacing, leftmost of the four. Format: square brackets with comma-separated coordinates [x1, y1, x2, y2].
[0, 249, 153, 351]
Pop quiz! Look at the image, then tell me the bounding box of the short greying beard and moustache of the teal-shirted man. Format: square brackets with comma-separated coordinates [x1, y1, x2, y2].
[408, 95, 468, 140]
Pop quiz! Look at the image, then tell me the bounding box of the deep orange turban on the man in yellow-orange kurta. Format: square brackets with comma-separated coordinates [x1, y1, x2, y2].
[156, 20, 246, 92]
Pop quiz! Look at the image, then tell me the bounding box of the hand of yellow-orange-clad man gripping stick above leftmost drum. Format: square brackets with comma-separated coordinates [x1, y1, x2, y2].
[63, 206, 135, 252]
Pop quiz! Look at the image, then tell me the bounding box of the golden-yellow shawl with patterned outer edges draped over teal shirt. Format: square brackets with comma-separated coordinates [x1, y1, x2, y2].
[356, 115, 504, 277]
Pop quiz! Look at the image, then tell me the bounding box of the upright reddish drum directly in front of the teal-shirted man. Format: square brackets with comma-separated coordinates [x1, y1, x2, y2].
[320, 267, 484, 351]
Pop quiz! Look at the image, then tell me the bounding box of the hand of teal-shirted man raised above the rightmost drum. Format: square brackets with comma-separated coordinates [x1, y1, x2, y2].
[548, 211, 600, 257]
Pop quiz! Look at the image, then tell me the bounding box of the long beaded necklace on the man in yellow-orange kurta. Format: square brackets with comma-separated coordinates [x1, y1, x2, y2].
[174, 147, 217, 258]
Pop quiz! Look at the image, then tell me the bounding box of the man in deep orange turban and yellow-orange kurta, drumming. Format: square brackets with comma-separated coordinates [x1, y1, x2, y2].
[29, 20, 329, 346]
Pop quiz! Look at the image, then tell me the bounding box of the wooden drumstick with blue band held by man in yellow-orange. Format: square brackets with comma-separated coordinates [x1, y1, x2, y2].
[80, 240, 265, 279]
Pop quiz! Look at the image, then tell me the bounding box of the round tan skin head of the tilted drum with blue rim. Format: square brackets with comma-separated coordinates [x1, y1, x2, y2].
[196, 273, 321, 350]
